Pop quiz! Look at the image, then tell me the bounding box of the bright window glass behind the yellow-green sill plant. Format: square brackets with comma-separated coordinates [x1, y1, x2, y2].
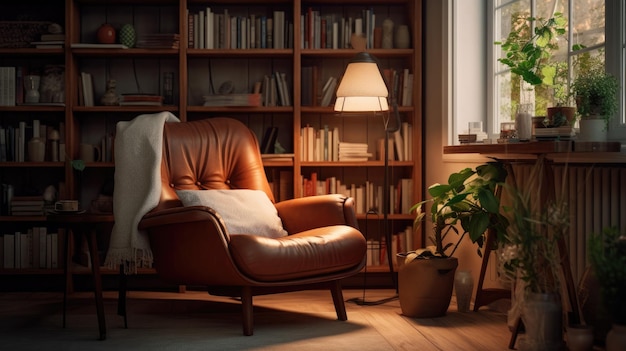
[490, 0, 605, 139]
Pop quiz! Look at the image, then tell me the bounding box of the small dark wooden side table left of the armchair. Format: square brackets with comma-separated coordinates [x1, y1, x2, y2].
[47, 213, 114, 340]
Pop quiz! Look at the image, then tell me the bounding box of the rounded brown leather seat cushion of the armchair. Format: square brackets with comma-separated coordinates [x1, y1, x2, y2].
[229, 225, 366, 282]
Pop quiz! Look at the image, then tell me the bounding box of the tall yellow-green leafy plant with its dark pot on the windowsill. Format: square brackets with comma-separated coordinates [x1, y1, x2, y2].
[494, 12, 575, 127]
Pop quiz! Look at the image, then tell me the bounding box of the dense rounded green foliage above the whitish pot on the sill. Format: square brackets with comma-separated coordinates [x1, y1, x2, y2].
[571, 68, 620, 126]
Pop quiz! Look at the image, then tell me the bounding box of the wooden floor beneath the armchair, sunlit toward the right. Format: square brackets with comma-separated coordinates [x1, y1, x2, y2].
[0, 290, 511, 351]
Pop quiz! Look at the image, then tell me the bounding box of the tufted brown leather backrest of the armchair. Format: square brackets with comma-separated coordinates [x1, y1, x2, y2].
[157, 117, 274, 209]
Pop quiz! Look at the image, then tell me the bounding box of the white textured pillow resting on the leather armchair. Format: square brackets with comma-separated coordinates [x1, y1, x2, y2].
[176, 189, 287, 238]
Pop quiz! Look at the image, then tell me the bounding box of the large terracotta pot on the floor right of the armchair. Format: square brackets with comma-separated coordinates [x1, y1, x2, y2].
[398, 257, 459, 318]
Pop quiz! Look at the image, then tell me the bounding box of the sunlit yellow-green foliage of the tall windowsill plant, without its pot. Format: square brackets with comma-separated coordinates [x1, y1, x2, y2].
[495, 12, 567, 86]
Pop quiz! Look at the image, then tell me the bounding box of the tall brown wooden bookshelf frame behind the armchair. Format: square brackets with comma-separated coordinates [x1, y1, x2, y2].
[0, 0, 423, 286]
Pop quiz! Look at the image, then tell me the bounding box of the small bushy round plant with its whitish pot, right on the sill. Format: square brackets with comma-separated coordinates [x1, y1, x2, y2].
[571, 68, 620, 141]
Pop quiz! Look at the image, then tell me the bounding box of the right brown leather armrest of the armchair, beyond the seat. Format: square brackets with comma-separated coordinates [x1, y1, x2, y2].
[276, 194, 358, 234]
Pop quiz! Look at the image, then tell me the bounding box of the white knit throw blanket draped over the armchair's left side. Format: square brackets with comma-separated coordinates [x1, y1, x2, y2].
[104, 112, 180, 273]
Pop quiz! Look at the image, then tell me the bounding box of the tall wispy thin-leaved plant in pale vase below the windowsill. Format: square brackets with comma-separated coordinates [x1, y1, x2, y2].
[498, 162, 569, 350]
